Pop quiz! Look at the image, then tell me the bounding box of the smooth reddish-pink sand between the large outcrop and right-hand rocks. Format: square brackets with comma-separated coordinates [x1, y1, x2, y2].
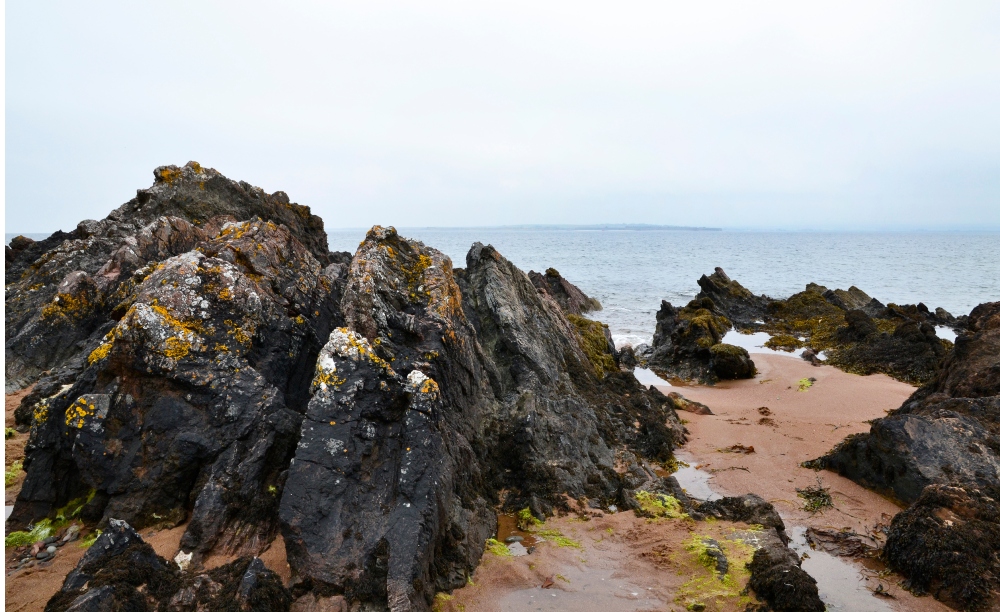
[661, 353, 949, 611]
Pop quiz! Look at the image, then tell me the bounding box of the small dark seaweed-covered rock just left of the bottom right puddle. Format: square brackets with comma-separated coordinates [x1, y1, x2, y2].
[747, 531, 826, 612]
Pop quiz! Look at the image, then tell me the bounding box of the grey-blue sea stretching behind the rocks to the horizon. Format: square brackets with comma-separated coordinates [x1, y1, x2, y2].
[7, 228, 1000, 347]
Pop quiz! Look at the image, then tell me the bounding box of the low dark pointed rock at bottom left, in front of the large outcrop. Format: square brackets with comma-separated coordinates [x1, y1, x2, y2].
[45, 519, 291, 612]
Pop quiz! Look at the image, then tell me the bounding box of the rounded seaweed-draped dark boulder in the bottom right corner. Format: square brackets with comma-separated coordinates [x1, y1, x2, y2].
[883, 485, 1000, 610]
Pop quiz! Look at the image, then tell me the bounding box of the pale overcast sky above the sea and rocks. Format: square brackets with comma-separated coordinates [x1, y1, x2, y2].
[5, 0, 1000, 232]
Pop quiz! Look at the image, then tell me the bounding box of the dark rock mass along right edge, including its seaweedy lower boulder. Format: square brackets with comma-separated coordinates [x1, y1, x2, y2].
[811, 302, 1000, 609]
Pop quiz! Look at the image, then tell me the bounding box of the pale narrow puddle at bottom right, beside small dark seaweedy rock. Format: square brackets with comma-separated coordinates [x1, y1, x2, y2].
[790, 525, 892, 612]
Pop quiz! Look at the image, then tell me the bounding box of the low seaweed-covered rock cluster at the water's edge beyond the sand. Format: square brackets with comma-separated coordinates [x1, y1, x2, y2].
[644, 268, 956, 384]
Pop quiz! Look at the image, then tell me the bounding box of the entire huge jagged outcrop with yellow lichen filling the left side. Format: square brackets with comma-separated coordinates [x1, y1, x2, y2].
[6, 162, 685, 610]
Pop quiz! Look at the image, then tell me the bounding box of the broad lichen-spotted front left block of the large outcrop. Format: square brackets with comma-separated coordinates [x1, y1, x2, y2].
[9, 215, 342, 556]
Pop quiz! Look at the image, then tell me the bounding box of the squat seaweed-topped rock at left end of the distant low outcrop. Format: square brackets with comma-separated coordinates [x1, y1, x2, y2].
[646, 296, 757, 383]
